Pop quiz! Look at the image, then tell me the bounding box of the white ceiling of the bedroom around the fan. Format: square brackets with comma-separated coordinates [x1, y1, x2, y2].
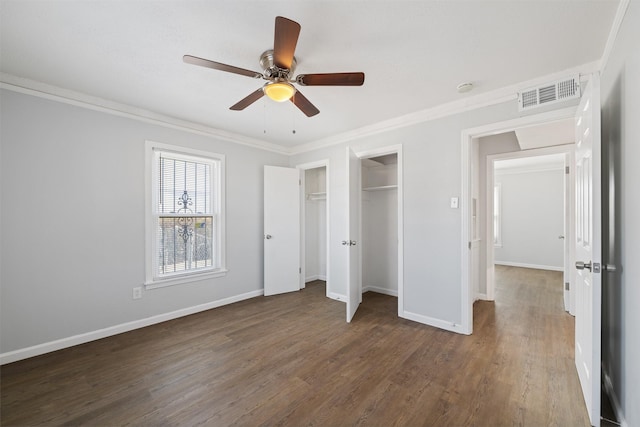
[0, 0, 619, 147]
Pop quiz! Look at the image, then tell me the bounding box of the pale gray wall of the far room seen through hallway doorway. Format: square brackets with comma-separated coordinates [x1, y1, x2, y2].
[494, 169, 564, 271]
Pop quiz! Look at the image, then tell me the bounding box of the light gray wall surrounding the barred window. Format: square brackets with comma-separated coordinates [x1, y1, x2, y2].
[0, 90, 288, 353]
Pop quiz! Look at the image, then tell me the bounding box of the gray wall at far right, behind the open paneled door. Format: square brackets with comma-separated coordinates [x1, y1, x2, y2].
[601, 1, 640, 426]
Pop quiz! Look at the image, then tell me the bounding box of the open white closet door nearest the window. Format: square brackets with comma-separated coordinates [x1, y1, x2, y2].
[264, 166, 300, 295]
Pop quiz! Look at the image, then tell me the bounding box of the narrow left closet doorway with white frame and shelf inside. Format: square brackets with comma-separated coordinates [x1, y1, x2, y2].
[298, 160, 331, 296]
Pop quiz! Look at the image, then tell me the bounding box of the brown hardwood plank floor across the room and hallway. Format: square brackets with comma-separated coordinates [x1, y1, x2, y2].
[0, 267, 589, 426]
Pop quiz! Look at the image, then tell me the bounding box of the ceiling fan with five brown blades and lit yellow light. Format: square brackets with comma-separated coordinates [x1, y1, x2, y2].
[183, 16, 364, 117]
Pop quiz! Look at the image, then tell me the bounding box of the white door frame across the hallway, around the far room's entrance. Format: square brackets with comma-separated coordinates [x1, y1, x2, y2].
[483, 143, 575, 306]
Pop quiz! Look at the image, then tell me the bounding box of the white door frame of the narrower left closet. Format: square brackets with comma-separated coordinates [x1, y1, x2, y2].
[295, 159, 331, 298]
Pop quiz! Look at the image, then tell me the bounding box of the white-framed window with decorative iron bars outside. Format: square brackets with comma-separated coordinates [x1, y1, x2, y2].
[146, 142, 226, 288]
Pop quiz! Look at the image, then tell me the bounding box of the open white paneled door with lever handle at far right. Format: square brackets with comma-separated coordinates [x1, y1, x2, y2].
[574, 74, 602, 426]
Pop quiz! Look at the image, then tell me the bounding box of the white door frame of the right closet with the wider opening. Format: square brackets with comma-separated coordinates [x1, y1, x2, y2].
[355, 144, 406, 317]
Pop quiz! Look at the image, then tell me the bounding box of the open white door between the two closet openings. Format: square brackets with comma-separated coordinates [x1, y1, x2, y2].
[342, 147, 362, 322]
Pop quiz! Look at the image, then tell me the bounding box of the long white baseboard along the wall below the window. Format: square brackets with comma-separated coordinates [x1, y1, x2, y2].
[0, 289, 264, 365]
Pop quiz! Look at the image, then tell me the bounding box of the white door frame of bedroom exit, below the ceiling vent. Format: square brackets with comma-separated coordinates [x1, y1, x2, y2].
[460, 106, 577, 335]
